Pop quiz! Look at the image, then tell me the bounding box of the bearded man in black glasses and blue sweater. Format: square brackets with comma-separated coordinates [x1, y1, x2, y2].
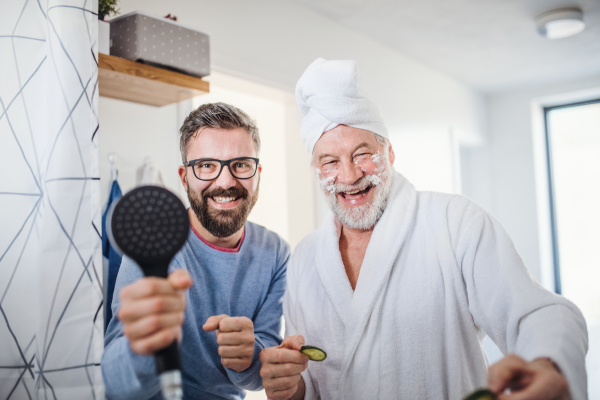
[102, 103, 290, 400]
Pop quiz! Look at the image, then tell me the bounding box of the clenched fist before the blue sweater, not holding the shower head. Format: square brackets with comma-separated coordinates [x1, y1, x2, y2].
[202, 314, 254, 372]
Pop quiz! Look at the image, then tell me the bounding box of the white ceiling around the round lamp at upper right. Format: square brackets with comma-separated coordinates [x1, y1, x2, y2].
[292, 0, 600, 93]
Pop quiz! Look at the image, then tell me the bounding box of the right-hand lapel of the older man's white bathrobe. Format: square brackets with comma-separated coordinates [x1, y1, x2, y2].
[338, 172, 417, 393]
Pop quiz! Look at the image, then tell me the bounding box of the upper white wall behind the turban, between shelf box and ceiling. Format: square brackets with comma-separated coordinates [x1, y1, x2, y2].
[113, 0, 485, 143]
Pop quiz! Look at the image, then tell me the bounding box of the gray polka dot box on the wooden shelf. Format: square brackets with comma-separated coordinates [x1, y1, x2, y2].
[110, 11, 210, 77]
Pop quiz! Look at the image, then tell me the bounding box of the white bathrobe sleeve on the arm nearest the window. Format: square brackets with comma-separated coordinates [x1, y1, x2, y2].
[449, 205, 588, 400]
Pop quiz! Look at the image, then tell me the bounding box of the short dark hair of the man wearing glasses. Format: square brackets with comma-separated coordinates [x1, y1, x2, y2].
[179, 103, 260, 163]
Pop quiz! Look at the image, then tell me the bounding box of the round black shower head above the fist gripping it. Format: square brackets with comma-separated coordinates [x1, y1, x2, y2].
[106, 186, 190, 278]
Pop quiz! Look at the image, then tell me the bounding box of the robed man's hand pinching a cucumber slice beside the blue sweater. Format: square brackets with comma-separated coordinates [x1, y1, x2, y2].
[260, 335, 308, 400]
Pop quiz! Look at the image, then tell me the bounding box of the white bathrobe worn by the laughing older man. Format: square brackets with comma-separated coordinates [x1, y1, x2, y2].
[284, 173, 587, 400]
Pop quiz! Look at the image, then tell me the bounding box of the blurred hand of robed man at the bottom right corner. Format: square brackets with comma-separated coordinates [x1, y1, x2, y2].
[488, 354, 571, 400]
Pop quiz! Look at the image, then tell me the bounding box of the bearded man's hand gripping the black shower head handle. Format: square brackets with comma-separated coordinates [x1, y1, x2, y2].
[117, 269, 192, 355]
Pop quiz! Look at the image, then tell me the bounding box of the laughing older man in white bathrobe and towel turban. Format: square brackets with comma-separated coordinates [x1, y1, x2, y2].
[261, 59, 587, 400]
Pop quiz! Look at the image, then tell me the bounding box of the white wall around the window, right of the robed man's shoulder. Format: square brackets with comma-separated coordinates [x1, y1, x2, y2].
[461, 76, 600, 289]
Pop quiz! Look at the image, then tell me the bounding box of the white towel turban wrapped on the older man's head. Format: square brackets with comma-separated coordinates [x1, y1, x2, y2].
[296, 58, 388, 154]
